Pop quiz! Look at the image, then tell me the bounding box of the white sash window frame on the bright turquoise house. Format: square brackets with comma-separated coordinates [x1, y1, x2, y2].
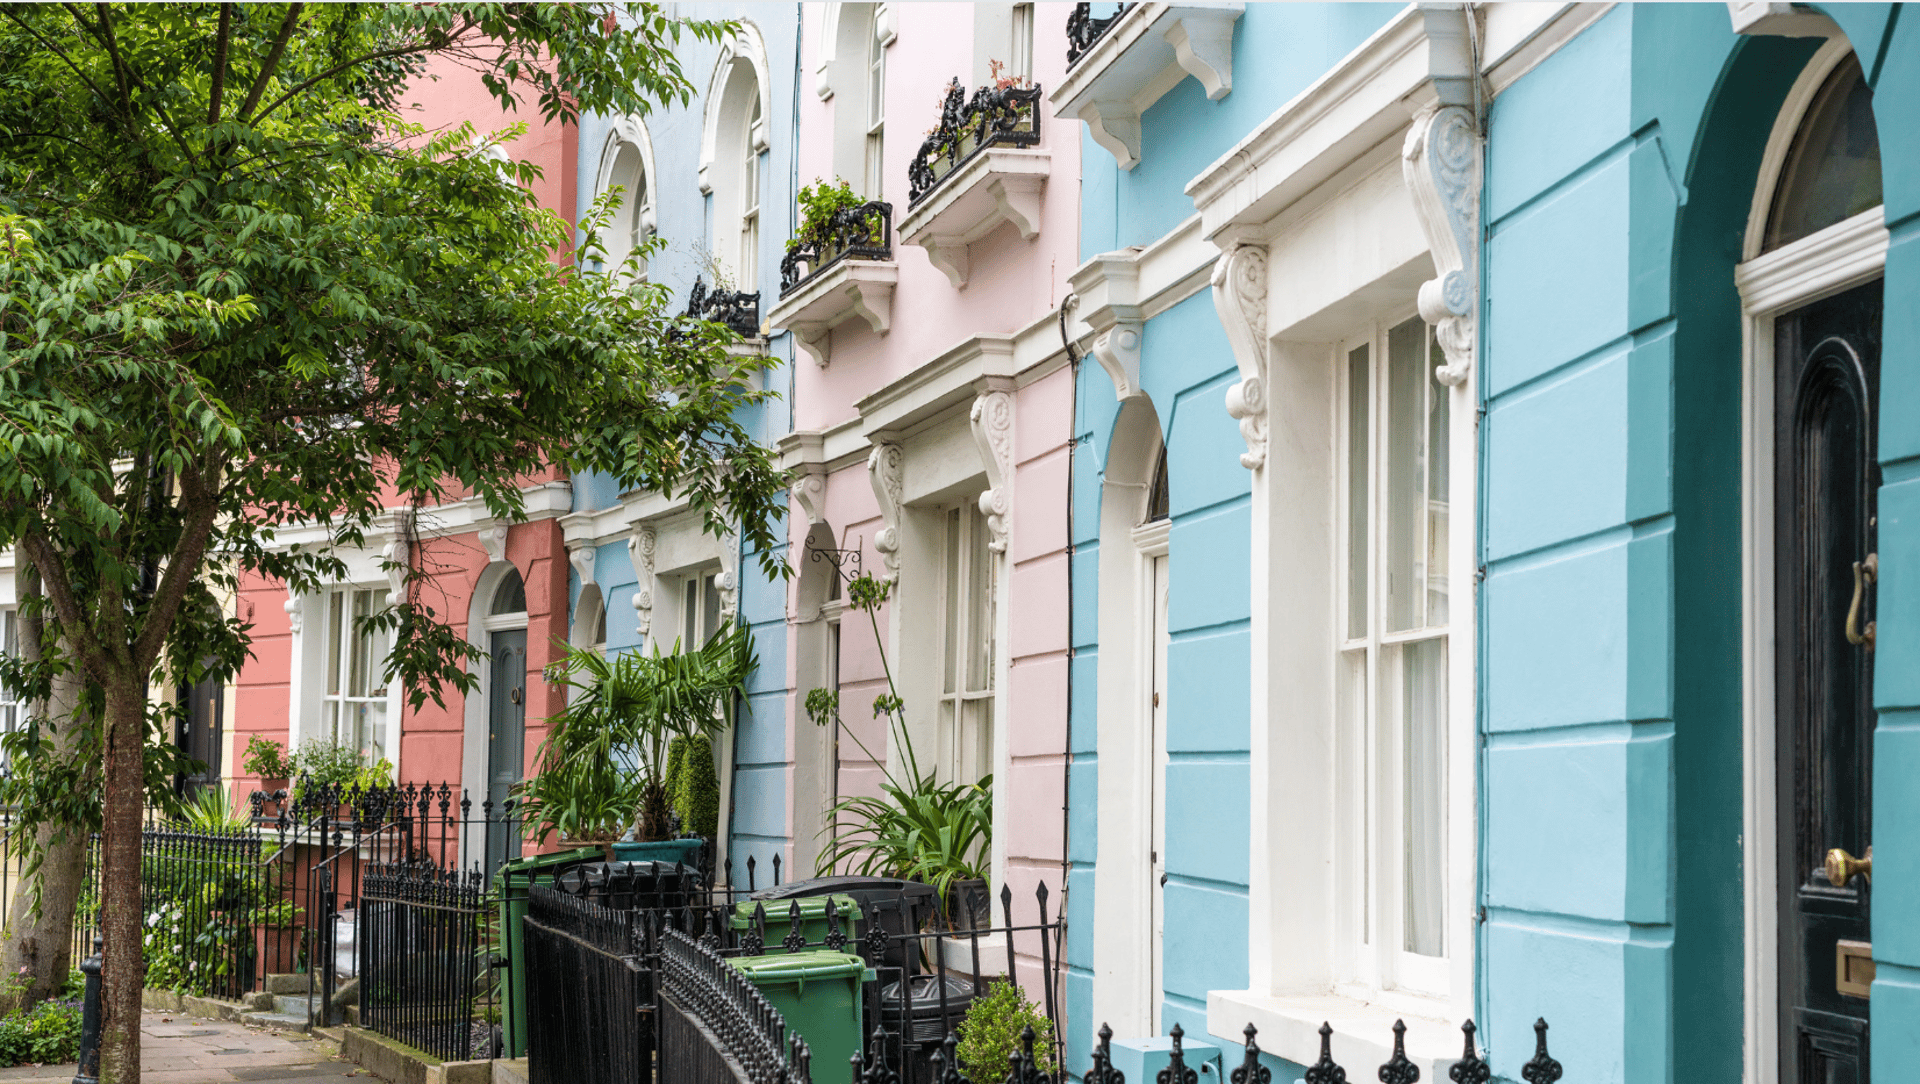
[1332, 313, 1451, 1000]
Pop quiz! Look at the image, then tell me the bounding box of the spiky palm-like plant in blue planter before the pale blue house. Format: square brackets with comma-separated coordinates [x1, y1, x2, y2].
[515, 627, 755, 842]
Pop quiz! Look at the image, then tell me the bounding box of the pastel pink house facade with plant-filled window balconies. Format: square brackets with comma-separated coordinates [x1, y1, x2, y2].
[768, 4, 1081, 963]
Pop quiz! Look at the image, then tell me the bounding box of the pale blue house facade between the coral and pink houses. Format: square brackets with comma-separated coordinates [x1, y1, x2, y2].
[563, 4, 799, 886]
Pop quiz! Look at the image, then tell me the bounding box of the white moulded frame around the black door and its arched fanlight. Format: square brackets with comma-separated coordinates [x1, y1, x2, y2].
[1734, 36, 1889, 1084]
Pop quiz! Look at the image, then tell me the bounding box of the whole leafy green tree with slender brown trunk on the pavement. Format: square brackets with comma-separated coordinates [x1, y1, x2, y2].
[0, 4, 783, 1082]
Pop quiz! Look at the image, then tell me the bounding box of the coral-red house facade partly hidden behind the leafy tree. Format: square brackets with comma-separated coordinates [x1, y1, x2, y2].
[221, 52, 578, 815]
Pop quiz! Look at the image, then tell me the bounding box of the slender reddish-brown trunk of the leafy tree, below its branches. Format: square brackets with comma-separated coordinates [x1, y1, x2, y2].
[100, 672, 146, 1084]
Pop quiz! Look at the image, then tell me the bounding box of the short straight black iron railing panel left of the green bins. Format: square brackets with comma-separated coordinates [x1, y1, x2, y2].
[357, 863, 501, 1061]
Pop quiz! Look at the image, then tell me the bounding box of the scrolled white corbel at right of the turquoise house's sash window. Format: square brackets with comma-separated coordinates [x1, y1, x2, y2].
[1400, 106, 1480, 388]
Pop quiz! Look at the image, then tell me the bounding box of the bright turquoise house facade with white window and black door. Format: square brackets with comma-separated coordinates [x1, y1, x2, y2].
[1050, 4, 1920, 1084]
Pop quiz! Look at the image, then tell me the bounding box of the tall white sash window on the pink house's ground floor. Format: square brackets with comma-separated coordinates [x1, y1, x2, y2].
[933, 497, 998, 783]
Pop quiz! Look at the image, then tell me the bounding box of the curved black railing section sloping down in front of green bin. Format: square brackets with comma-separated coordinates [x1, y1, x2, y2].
[659, 929, 812, 1084]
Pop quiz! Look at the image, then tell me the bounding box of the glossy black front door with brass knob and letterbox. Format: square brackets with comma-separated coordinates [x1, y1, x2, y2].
[1774, 274, 1882, 1084]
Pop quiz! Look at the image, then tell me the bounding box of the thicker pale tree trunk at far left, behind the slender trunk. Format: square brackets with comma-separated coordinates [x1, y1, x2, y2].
[0, 562, 86, 1011]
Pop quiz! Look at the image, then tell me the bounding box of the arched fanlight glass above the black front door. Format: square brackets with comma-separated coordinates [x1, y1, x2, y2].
[1761, 54, 1880, 251]
